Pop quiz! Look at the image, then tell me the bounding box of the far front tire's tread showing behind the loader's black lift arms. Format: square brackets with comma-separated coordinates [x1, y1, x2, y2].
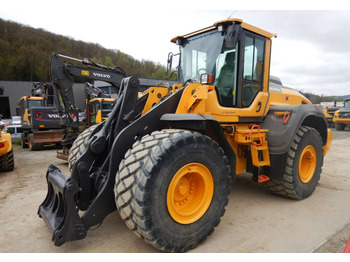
[68, 125, 97, 171]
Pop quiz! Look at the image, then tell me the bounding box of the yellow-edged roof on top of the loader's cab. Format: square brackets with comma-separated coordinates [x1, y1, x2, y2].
[171, 18, 277, 43]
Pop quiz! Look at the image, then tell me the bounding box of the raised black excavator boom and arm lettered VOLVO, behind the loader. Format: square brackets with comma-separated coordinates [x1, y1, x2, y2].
[50, 53, 126, 160]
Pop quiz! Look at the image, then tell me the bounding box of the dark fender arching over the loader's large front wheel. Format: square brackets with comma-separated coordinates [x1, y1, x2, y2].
[160, 114, 236, 180]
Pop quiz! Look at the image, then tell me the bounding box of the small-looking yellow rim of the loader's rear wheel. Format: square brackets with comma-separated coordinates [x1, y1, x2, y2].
[299, 145, 317, 184]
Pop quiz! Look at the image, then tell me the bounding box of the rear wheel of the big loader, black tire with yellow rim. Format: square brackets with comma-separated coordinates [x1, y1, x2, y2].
[264, 126, 323, 200]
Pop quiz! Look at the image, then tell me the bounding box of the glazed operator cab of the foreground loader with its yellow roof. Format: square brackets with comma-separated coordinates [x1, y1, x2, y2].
[172, 19, 276, 108]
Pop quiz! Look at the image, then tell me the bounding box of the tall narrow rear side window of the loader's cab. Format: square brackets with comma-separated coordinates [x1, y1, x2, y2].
[242, 34, 265, 107]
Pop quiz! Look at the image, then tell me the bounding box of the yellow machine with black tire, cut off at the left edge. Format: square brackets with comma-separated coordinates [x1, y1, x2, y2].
[0, 130, 15, 172]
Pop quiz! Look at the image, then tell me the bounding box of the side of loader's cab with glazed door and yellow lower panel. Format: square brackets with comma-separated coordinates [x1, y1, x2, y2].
[206, 30, 271, 123]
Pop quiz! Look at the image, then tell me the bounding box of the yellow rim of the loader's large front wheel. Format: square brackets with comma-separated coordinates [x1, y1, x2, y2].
[167, 163, 214, 224]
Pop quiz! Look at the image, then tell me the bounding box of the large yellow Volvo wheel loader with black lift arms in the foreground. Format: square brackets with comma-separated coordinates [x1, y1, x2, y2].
[38, 18, 331, 252]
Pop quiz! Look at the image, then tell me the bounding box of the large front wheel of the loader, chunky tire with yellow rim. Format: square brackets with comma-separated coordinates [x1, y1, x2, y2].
[114, 129, 230, 252]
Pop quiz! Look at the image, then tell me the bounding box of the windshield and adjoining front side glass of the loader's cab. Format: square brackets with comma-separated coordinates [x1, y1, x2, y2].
[179, 30, 238, 107]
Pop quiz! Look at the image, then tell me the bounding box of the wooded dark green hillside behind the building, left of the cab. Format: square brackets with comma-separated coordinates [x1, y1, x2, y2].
[0, 19, 170, 81]
